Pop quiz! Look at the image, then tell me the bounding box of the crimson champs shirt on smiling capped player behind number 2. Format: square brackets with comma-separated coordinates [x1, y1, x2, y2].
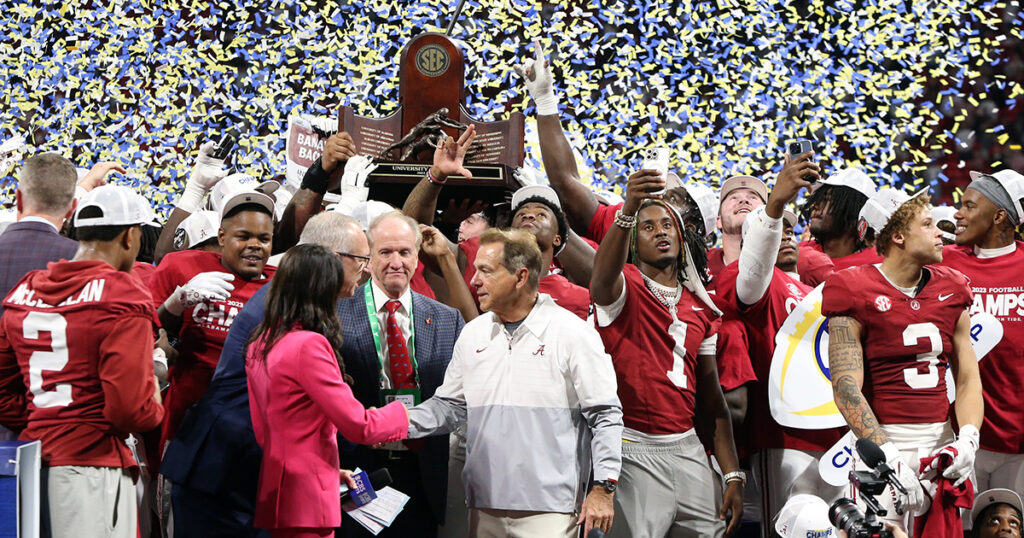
[150, 250, 274, 445]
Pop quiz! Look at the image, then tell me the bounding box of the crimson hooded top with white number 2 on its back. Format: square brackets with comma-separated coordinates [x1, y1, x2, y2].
[0, 260, 164, 468]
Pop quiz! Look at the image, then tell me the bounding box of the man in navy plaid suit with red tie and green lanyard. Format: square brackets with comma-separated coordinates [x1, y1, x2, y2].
[338, 211, 465, 537]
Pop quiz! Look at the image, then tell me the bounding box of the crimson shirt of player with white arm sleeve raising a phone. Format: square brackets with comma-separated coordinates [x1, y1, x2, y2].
[715, 261, 843, 451]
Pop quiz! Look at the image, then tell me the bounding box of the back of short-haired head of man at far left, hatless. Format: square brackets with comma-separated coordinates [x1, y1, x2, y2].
[17, 153, 78, 217]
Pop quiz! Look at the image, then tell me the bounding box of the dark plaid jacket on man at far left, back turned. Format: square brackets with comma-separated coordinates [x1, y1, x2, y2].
[0, 222, 78, 315]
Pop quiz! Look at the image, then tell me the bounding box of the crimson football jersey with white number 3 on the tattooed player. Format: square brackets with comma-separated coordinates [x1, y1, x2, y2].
[821, 265, 972, 424]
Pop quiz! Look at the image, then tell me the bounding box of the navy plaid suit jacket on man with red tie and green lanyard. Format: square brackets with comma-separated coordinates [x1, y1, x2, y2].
[338, 283, 466, 522]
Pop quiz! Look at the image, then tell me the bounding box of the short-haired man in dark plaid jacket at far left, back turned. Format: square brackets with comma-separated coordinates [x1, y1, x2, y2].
[0, 153, 78, 315]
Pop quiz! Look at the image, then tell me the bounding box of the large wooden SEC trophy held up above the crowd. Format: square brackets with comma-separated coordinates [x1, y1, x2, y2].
[338, 33, 525, 207]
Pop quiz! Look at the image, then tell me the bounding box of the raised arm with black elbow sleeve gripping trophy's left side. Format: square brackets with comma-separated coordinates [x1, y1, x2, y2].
[273, 131, 355, 253]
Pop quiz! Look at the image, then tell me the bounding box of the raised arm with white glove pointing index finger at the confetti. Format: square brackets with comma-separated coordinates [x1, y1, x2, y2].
[515, 41, 597, 234]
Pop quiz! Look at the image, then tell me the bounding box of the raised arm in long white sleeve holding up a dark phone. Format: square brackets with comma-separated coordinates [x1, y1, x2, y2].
[736, 152, 818, 307]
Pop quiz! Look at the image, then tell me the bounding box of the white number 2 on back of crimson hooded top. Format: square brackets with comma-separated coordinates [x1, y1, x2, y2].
[22, 312, 71, 408]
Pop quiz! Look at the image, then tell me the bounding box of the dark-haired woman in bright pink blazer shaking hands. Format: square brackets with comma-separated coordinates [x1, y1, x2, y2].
[246, 245, 409, 538]
